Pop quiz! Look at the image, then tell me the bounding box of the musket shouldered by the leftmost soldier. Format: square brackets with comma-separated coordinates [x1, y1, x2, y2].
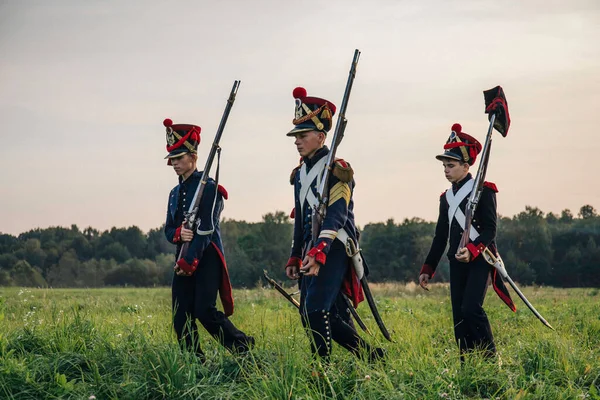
[178, 80, 241, 260]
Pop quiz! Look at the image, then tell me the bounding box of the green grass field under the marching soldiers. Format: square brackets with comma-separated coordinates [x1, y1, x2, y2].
[0, 284, 600, 399]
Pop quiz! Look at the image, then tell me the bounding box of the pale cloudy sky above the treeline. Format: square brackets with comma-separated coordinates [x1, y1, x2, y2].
[0, 0, 600, 235]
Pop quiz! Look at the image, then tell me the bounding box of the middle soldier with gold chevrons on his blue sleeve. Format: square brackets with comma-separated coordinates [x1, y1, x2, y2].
[285, 88, 383, 360]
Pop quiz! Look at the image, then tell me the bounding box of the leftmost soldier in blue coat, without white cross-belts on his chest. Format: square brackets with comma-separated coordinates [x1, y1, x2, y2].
[164, 119, 254, 360]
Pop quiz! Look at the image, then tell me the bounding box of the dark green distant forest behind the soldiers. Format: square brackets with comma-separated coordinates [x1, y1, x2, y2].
[0, 205, 600, 288]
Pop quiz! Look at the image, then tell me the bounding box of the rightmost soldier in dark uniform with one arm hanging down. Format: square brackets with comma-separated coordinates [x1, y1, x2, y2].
[419, 124, 514, 360]
